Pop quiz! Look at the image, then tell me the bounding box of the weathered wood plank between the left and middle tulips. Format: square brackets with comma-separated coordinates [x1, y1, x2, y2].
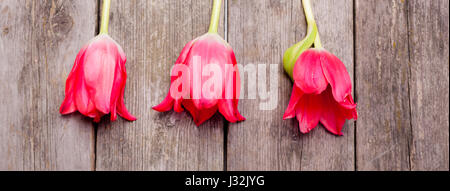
[97, 0, 224, 170]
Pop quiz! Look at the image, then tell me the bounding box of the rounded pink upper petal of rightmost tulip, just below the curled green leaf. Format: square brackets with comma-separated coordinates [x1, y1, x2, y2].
[293, 49, 328, 94]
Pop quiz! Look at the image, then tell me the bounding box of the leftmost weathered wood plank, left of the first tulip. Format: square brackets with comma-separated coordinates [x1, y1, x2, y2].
[0, 0, 97, 170]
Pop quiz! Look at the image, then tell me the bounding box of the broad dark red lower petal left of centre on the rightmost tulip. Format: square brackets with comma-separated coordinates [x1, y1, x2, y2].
[296, 95, 323, 133]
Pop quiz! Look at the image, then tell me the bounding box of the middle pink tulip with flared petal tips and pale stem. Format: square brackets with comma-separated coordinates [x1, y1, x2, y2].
[153, 0, 245, 126]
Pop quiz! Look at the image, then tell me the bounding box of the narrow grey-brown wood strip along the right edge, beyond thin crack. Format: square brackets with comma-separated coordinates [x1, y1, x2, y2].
[408, 0, 449, 170]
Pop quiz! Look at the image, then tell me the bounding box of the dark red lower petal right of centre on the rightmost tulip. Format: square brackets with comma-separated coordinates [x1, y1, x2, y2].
[320, 88, 345, 136]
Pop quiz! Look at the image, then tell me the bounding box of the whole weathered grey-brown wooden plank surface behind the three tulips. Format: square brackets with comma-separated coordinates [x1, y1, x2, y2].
[0, 0, 449, 171]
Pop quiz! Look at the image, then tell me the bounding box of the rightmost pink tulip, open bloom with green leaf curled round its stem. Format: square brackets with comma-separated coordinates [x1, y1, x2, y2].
[283, 0, 358, 135]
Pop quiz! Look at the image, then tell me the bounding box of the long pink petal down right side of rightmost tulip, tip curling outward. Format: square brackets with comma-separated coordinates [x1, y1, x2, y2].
[322, 50, 356, 104]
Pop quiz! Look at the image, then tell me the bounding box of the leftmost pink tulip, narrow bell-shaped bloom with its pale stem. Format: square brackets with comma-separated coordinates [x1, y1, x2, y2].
[60, 0, 136, 122]
